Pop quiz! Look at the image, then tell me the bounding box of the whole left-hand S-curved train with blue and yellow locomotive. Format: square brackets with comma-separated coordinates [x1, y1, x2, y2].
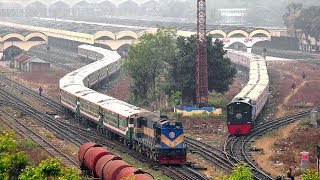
[59, 45, 186, 164]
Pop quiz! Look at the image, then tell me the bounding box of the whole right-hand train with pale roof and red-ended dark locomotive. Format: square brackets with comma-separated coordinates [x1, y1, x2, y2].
[227, 50, 269, 135]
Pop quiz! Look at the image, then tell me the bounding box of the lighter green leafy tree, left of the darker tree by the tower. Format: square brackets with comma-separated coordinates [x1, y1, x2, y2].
[124, 28, 177, 105]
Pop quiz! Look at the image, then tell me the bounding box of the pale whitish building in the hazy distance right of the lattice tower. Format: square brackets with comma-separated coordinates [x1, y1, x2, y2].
[218, 8, 247, 25]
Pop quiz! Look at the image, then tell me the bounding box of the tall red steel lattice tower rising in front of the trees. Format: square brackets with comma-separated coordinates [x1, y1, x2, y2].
[197, 0, 208, 106]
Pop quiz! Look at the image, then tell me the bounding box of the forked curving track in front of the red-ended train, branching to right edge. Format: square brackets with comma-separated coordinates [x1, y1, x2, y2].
[224, 107, 320, 179]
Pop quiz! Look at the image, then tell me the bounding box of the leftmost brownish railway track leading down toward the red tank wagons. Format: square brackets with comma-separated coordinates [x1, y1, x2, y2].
[0, 101, 78, 166]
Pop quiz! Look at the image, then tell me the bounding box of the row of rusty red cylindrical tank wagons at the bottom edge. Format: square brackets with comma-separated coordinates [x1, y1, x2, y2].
[78, 142, 154, 180]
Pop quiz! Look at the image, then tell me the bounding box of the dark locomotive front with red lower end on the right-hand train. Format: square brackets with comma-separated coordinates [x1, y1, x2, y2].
[227, 98, 253, 135]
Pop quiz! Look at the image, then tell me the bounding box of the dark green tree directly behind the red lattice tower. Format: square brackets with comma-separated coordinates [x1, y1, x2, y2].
[168, 36, 236, 102]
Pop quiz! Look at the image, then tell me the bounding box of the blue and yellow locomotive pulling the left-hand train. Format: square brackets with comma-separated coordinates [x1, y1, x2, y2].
[133, 113, 187, 164]
